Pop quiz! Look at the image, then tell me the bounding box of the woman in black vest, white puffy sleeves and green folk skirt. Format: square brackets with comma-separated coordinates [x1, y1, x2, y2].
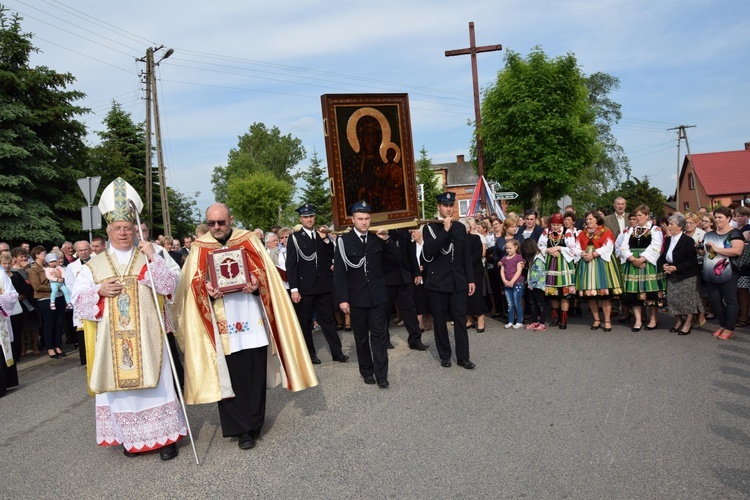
[620, 205, 666, 332]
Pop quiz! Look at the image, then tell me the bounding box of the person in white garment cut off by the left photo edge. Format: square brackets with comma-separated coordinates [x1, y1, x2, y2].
[0, 262, 23, 398]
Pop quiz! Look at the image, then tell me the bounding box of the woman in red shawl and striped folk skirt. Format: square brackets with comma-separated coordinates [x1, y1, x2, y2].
[576, 210, 622, 332]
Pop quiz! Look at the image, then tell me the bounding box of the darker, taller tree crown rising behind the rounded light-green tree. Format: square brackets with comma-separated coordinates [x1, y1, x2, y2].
[211, 122, 306, 202]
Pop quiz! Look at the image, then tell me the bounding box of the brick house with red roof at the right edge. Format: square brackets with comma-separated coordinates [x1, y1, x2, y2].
[676, 142, 750, 212]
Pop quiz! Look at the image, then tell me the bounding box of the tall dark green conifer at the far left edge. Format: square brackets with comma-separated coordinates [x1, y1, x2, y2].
[0, 9, 89, 245]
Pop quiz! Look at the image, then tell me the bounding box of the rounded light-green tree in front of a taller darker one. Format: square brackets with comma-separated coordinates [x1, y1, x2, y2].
[227, 172, 294, 230]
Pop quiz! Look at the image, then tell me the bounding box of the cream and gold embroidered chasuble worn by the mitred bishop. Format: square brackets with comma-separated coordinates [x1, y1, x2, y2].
[86, 248, 163, 394]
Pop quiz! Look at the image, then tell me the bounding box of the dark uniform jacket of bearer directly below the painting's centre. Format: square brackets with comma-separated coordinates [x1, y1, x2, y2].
[333, 230, 401, 307]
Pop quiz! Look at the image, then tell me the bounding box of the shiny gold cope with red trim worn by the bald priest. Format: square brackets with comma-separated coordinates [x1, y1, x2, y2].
[172, 228, 318, 404]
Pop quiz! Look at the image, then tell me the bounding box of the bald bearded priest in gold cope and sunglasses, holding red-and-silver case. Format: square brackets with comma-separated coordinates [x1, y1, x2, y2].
[172, 203, 318, 449]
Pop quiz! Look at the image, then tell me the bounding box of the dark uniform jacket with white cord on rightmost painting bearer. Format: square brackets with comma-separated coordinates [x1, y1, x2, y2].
[422, 221, 476, 293]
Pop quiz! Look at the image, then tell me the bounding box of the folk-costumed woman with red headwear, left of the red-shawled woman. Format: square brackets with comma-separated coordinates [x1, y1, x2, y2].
[539, 213, 581, 330]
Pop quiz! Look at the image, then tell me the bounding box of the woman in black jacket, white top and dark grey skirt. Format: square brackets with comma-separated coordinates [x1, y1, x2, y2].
[659, 214, 703, 335]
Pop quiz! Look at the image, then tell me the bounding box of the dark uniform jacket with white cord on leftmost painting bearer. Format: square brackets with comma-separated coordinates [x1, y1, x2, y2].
[286, 229, 335, 295]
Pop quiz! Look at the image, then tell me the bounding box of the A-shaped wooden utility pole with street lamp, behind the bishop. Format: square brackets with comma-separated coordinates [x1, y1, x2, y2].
[138, 45, 174, 236]
